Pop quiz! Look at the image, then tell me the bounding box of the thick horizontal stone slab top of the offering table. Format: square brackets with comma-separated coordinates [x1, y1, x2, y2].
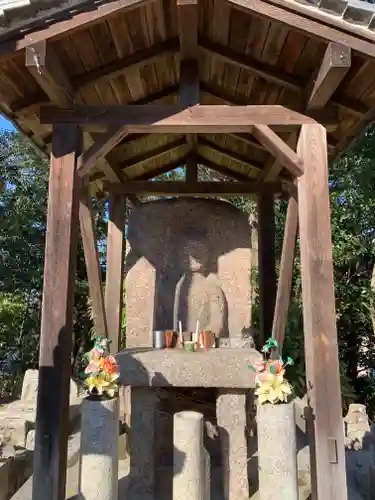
[116, 348, 262, 389]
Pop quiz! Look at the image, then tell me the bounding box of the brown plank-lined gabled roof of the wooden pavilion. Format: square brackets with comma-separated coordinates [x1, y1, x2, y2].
[0, 0, 375, 191]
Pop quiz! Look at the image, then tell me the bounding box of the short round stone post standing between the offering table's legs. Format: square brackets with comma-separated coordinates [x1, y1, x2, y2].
[173, 411, 207, 500]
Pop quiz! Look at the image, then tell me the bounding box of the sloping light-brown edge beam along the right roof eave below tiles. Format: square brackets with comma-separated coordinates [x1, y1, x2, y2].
[228, 0, 375, 58]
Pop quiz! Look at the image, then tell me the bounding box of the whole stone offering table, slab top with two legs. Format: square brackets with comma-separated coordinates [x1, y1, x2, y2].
[116, 348, 262, 500]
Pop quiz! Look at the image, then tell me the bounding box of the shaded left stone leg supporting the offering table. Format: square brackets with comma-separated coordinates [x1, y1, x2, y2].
[129, 387, 157, 500]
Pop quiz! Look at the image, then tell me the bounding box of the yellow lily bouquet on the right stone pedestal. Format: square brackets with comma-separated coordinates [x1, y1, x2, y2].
[249, 338, 293, 404]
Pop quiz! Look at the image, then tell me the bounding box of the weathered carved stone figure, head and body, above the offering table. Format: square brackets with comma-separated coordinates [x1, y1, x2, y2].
[173, 229, 228, 337]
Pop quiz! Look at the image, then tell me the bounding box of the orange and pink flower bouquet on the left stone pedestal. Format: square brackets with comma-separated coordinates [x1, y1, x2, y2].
[84, 336, 120, 398]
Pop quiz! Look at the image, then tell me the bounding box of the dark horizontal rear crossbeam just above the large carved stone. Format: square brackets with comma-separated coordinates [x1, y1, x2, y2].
[105, 180, 280, 196]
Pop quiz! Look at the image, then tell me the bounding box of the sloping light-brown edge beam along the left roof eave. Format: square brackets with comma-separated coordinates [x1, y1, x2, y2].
[0, 0, 153, 57]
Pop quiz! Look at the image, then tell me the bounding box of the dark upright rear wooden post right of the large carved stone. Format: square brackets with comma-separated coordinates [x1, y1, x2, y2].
[258, 191, 276, 347]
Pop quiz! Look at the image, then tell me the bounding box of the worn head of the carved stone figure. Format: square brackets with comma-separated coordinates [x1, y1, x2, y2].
[183, 229, 209, 273]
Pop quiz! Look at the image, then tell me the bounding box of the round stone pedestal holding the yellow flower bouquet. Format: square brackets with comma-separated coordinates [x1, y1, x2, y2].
[257, 403, 298, 500]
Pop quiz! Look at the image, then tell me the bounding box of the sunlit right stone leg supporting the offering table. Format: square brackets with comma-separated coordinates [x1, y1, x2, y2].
[216, 389, 250, 500]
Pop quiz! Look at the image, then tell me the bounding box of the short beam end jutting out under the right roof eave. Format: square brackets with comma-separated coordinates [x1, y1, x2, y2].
[307, 42, 351, 109]
